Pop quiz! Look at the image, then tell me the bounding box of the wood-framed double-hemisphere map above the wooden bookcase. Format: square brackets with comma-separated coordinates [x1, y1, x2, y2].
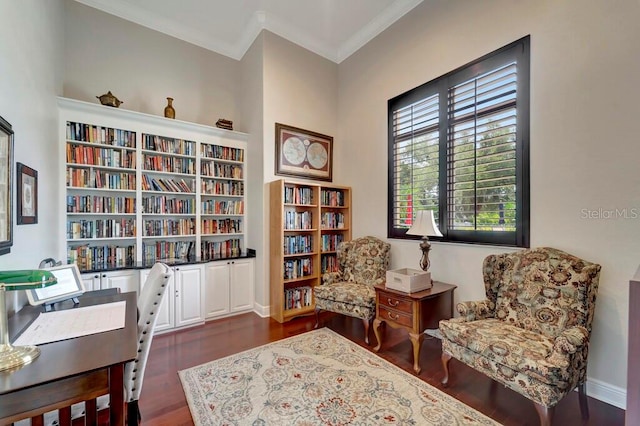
[275, 123, 333, 182]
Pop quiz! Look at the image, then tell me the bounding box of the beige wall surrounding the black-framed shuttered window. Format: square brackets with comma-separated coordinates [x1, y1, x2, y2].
[336, 0, 640, 406]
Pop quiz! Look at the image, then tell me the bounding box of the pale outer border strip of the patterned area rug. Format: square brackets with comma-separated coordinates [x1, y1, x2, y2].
[178, 326, 501, 426]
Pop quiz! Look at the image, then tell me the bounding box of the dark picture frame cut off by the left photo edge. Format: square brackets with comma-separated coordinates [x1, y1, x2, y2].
[0, 117, 13, 255]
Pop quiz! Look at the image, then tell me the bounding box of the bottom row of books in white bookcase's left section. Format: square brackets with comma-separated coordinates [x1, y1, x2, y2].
[67, 245, 136, 271]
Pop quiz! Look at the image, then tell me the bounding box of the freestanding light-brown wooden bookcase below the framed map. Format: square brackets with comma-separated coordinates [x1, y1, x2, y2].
[269, 180, 351, 322]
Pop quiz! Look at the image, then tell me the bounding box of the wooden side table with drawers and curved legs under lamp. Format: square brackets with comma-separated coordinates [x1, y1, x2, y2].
[373, 281, 456, 374]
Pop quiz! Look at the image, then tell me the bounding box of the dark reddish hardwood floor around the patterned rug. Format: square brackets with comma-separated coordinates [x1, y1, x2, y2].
[140, 313, 624, 426]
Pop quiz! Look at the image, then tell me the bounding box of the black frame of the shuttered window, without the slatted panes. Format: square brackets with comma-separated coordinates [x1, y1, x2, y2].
[387, 36, 530, 247]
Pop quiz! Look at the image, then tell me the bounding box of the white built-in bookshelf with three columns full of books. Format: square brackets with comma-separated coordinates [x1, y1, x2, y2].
[59, 98, 247, 270]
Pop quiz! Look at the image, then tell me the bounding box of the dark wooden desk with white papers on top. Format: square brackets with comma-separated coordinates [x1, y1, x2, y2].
[0, 291, 138, 426]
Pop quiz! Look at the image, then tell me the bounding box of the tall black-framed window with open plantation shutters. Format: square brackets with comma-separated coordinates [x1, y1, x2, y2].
[388, 37, 529, 247]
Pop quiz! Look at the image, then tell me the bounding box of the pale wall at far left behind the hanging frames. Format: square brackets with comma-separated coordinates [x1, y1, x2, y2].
[0, 0, 64, 311]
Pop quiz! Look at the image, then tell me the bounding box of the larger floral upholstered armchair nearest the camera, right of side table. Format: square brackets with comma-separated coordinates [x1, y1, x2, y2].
[440, 247, 600, 425]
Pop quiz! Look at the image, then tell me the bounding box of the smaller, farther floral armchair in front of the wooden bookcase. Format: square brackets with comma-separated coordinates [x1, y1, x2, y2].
[313, 237, 391, 344]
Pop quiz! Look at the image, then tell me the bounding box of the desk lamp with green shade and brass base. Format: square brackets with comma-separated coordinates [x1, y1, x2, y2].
[0, 269, 58, 371]
